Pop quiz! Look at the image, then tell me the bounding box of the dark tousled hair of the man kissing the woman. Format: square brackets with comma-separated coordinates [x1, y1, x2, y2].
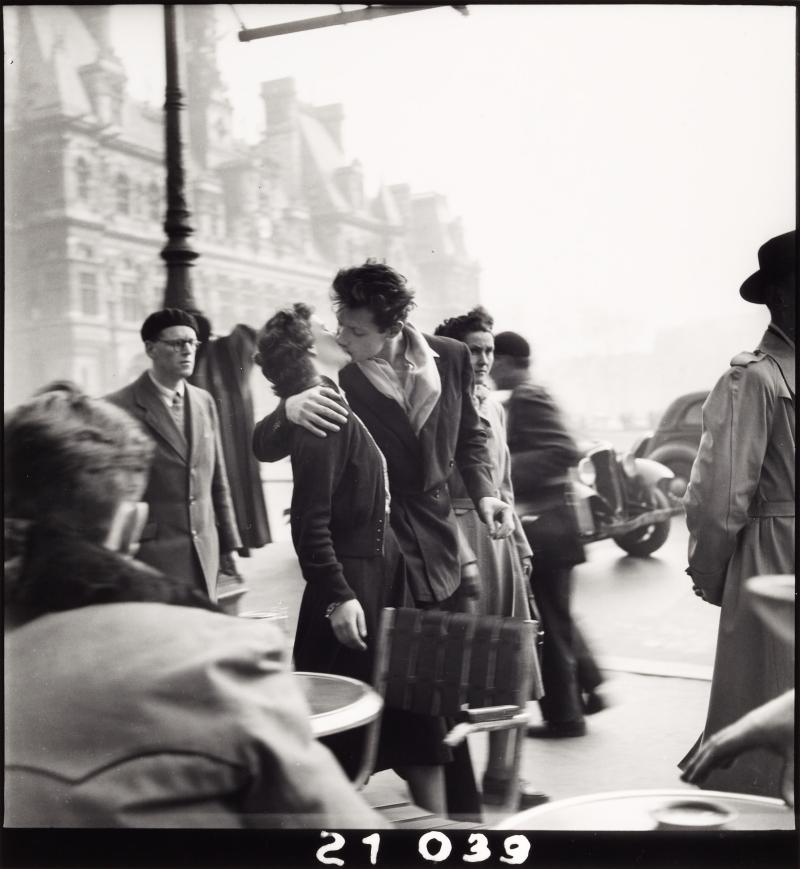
[332, 259, 415, 332]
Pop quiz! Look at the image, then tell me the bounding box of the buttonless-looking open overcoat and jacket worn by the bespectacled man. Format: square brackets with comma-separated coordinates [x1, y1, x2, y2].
[107, 371, 241, 600]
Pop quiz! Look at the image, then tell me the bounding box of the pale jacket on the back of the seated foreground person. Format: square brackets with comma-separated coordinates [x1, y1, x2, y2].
[4, 602, 386, 829]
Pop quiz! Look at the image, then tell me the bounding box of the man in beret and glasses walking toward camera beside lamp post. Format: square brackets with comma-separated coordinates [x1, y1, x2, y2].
[107, 308, 242, 600]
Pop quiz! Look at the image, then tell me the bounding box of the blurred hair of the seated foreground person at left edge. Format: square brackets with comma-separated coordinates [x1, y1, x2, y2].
[4, 384, 155, 543]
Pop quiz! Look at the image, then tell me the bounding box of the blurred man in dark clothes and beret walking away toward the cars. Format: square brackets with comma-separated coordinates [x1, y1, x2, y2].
[492, 332, 605, 738]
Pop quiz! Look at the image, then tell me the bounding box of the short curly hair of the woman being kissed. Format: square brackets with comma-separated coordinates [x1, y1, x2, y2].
[255, 302, 317, 398]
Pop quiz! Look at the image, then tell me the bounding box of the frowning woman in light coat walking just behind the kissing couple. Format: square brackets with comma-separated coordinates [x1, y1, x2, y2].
[434, 307, 547, 808]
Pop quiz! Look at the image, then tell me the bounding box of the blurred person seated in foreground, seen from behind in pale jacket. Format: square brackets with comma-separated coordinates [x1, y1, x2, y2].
[5, 387, 385, 827]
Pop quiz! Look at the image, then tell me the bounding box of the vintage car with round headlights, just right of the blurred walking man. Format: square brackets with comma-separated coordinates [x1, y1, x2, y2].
[569, 443, 682, 558]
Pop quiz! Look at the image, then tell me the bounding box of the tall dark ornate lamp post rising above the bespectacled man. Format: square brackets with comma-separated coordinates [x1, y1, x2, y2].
[161, 4, 198, 311]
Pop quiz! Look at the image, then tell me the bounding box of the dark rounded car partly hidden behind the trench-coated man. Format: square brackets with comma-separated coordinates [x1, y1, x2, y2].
[631, 389, 708, 495]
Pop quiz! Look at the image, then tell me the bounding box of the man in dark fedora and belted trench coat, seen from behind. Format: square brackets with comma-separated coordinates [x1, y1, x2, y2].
[681, 231, 797, 796]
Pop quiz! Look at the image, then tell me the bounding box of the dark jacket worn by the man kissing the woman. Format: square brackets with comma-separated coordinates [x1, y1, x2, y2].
[253, 335, 495, 602]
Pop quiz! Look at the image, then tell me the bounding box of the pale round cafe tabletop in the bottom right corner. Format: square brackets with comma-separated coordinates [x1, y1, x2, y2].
[496, 788, 795, 831]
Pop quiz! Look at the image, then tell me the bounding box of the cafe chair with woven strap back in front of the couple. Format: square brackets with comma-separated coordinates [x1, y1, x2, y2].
[373, 608, 543, 811]
